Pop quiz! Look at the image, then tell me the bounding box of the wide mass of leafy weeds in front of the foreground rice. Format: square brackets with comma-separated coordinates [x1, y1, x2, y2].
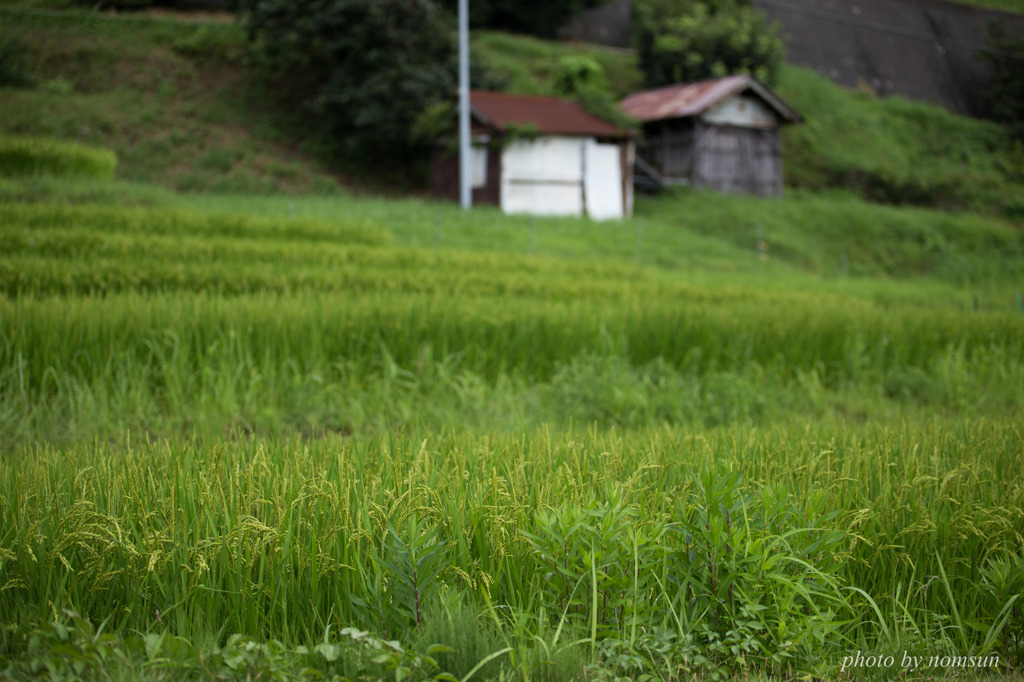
[523, 469, 848, 679]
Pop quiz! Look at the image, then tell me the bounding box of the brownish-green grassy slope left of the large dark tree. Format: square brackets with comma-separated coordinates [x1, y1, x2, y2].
[0, 7, 338, 193]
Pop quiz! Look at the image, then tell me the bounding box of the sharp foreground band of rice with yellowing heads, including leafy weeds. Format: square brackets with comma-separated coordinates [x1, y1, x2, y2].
[0, 419, 1024, 676]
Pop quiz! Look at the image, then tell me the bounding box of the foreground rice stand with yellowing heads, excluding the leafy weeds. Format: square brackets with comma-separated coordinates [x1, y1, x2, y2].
[0, 421, 1024, 663]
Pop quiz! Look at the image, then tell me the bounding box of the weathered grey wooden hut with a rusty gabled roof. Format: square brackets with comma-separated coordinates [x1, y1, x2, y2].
[621, 75, 803, 197]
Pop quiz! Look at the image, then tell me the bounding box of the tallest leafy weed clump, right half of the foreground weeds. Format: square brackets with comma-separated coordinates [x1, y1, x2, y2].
[671, 470, 846, 669]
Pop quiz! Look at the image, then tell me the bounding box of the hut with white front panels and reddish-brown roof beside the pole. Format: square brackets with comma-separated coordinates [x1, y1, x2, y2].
[433, 90, 634, 220]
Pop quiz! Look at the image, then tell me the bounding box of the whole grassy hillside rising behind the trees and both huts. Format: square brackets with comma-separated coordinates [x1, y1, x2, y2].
[0, 7, 1024, 220]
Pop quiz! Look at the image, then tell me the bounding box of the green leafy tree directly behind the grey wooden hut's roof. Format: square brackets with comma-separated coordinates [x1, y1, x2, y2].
[633, 0, 784, 87]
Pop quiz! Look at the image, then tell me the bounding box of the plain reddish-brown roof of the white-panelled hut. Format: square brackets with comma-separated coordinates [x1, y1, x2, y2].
[469, 90, 630, 137]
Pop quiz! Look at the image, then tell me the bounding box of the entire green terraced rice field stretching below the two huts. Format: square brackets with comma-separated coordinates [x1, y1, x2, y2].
[0, 193, 1024, 680]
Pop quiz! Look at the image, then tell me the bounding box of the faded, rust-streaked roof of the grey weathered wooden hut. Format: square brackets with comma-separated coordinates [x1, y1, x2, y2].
[620, 75, 803, 123]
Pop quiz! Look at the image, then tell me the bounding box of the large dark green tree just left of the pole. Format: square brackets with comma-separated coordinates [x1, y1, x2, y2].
[240, 0, 457, 159]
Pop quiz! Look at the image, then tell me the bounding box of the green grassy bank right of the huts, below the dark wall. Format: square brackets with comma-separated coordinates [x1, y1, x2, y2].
[778, 68, 1024, 221]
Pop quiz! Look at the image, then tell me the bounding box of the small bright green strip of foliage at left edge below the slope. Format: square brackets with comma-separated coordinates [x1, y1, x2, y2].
[0, 137, 118, 180]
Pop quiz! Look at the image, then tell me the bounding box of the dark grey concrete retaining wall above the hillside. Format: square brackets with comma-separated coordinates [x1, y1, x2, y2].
[563, 0, 1024, 116]
